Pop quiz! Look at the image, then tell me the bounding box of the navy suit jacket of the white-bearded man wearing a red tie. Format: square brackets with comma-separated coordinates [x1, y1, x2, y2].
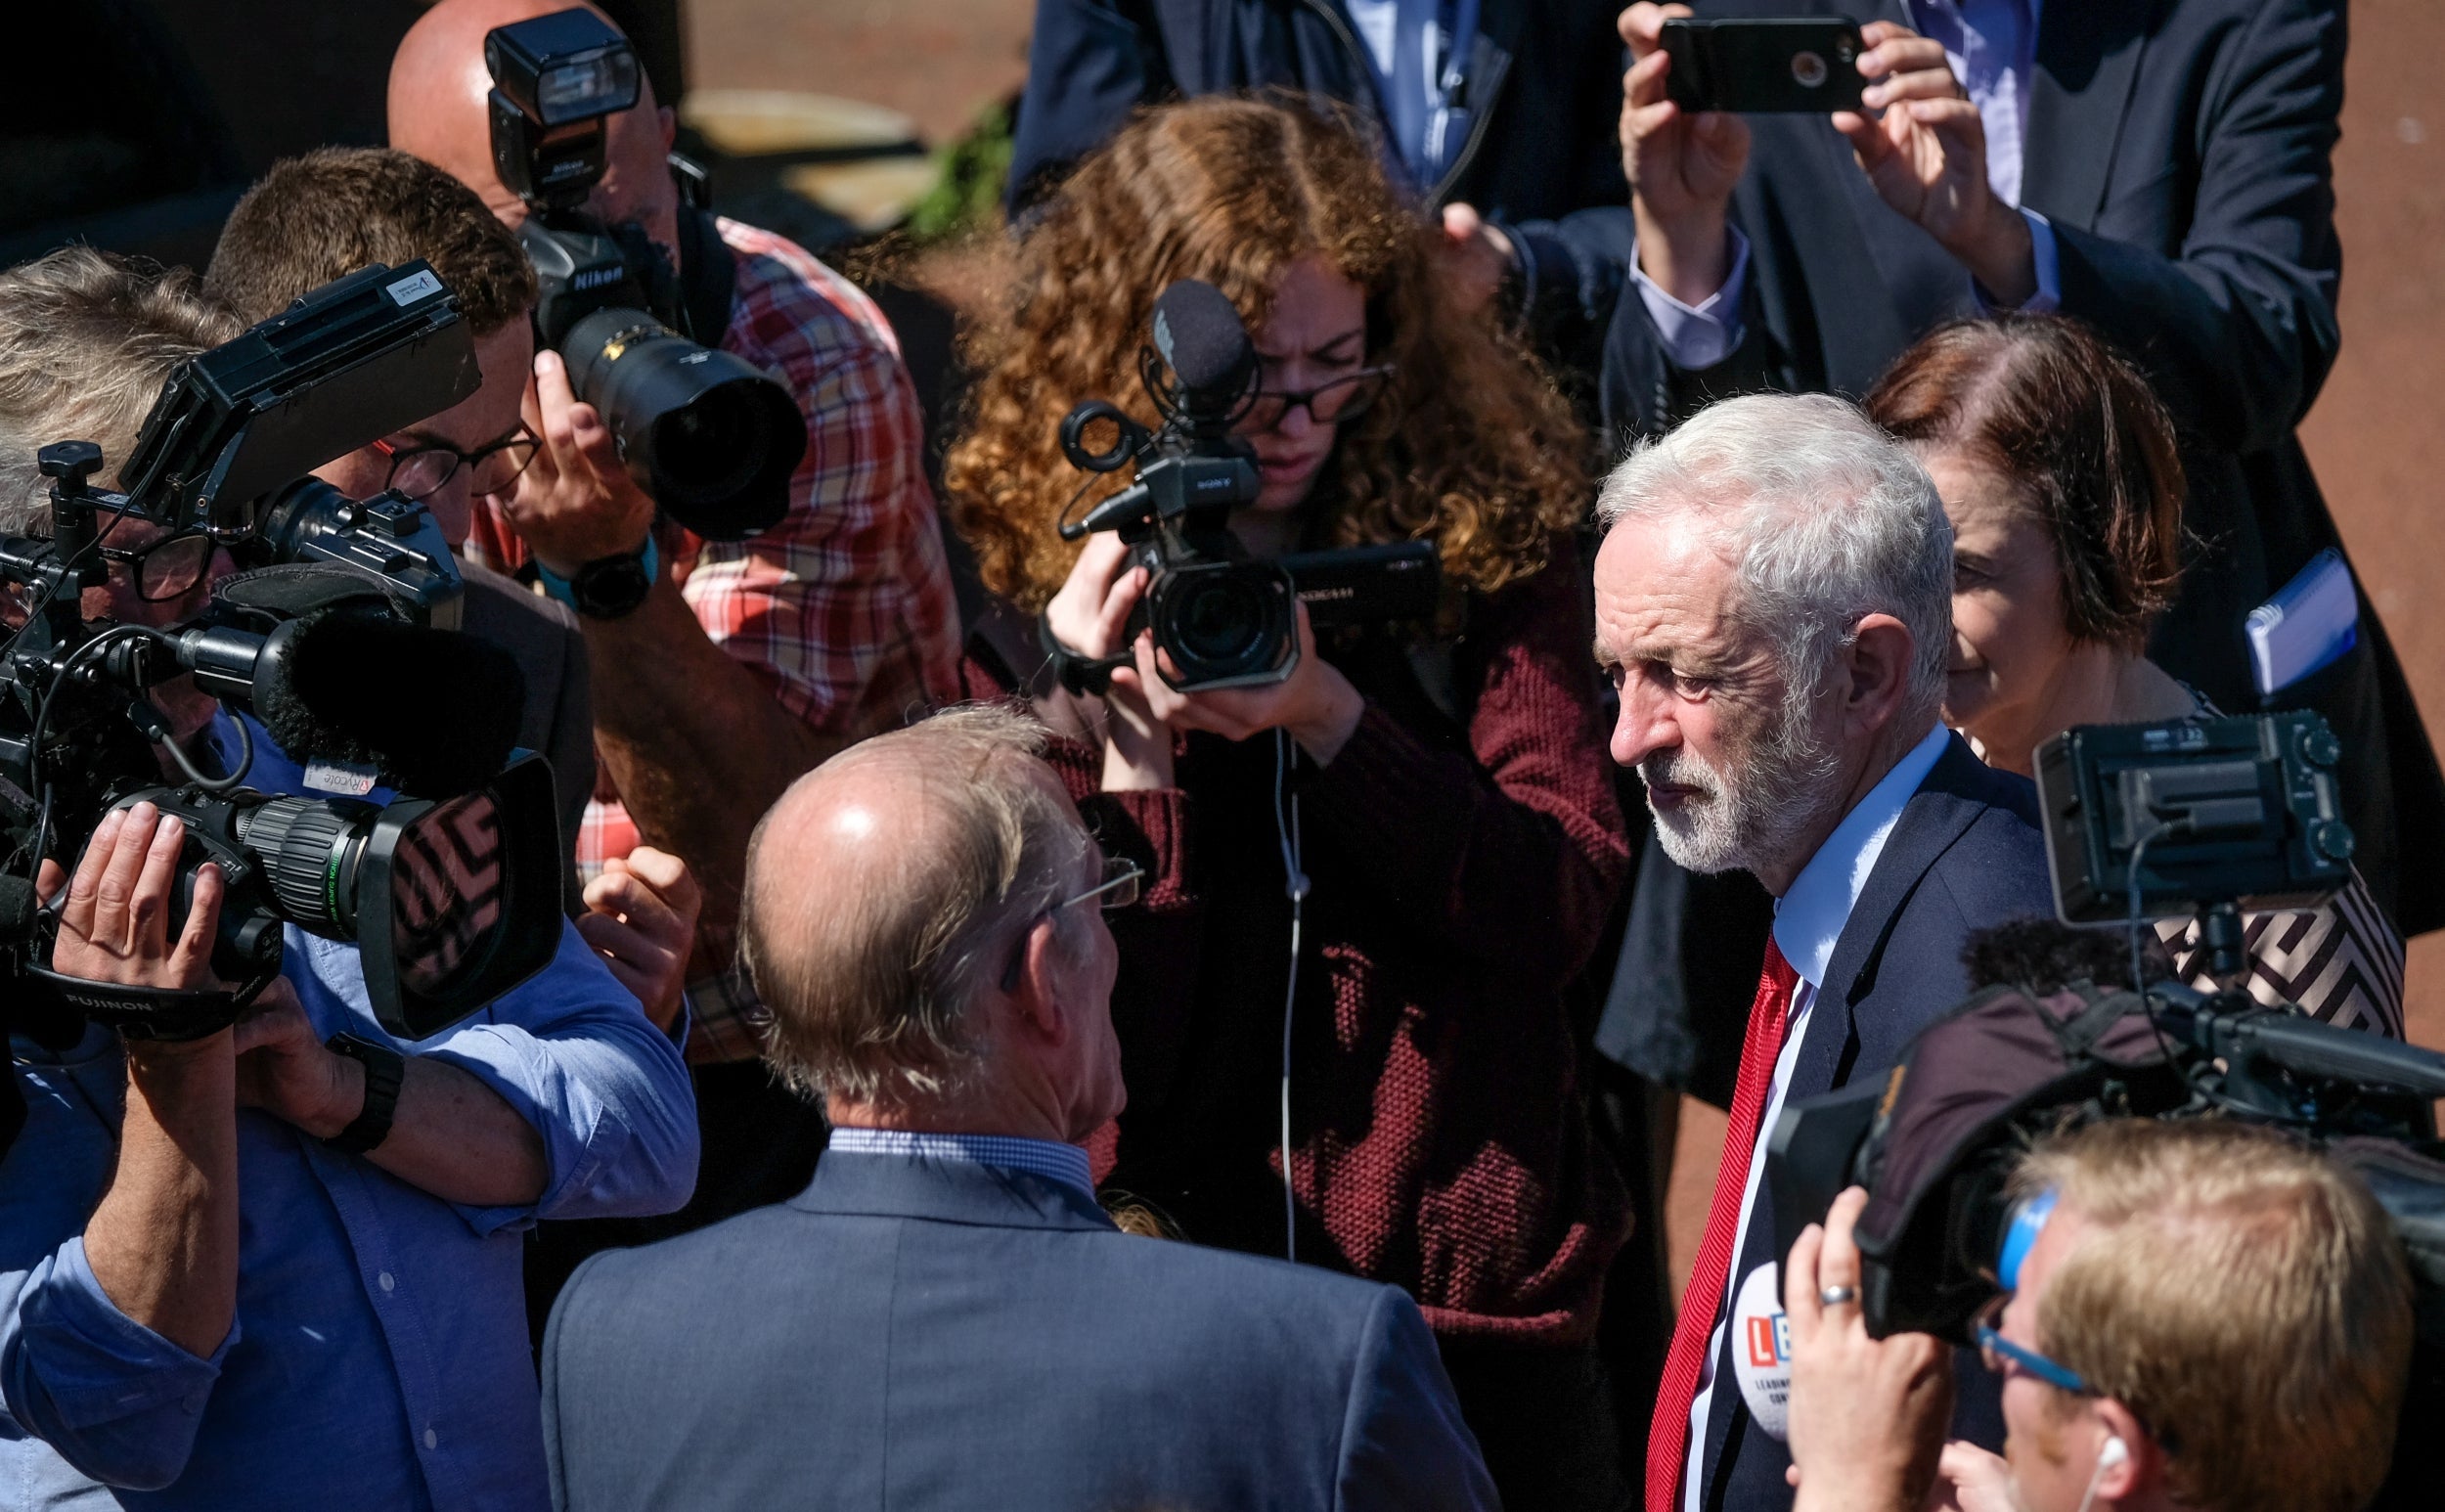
[1700, 729, 2054, 1512]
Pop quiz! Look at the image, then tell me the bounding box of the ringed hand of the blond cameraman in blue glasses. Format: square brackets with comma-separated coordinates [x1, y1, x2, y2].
[1783, 1186, 1954, 1512]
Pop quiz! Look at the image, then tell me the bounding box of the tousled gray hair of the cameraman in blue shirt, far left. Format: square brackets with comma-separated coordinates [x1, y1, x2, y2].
[0, 247, 240, 536]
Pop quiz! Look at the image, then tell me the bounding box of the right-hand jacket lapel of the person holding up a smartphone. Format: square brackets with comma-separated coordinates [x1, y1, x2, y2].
[2020, 0, 2164, 230]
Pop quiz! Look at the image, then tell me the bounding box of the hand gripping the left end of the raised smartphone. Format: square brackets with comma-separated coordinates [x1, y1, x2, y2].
[1617, 0, 1749, 303]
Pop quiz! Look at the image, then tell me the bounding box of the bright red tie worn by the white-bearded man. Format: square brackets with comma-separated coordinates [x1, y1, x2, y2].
[1648, 935, 1800, 1512]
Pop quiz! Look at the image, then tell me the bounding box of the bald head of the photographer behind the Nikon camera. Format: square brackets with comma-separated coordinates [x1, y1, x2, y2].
[389, 0, 680, 249]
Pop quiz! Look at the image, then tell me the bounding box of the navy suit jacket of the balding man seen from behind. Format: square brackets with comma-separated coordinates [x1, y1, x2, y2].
[543, 1152, 1494, 1512]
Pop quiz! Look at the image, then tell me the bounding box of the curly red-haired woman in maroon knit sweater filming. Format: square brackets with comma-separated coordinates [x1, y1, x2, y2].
[949, 98, 1626, 1507]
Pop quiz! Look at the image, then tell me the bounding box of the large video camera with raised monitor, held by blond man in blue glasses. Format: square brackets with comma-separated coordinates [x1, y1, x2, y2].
[1765, 712, 2445, 1504]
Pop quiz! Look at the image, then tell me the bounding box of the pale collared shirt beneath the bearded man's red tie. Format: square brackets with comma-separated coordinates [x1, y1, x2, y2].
[1682, 724, 1954, 1512]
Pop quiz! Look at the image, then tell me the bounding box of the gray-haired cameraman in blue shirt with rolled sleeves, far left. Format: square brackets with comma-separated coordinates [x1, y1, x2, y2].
[0, 252, 697, 1509]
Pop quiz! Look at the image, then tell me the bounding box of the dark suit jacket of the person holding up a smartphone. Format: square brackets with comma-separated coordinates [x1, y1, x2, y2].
[1531, 0, 2445, 935]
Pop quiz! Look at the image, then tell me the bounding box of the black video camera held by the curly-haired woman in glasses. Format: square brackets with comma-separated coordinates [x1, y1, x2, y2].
[1042, 279, 1443, 692]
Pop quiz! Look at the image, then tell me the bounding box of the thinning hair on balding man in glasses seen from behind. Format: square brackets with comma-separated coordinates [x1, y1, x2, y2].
[738, 704, 1095, 1103]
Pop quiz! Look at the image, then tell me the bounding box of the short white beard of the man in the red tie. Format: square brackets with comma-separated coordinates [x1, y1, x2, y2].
[1638, 689, 1842, 873]
